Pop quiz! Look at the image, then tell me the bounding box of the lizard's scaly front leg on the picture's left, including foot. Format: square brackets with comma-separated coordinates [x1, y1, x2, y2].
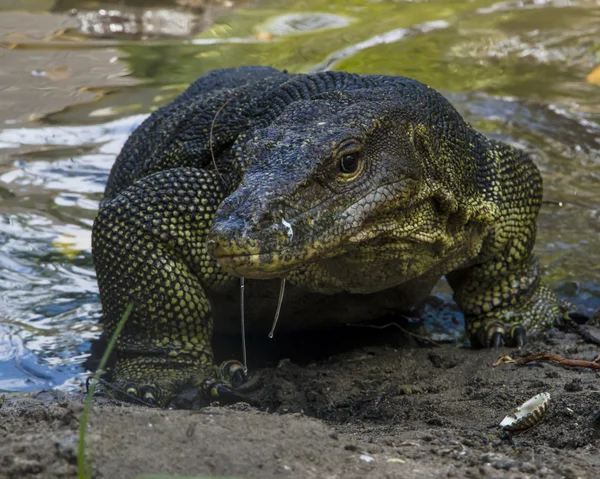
[92, 168, 243, 406]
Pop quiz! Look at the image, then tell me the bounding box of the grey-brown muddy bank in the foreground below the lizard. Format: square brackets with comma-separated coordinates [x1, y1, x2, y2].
[0, 332, 600, 478]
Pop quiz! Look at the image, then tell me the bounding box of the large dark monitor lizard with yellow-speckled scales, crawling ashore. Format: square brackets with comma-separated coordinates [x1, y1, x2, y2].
[93, 67, 568, 405]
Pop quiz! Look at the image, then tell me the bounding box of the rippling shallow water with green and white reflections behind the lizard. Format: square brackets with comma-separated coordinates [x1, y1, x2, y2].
[0, 0, 600, 391]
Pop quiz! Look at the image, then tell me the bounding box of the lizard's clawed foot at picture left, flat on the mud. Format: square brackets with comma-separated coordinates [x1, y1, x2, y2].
[108, 357, 246, 407]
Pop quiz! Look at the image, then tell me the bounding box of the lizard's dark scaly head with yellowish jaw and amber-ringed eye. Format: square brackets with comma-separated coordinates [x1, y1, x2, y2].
[207, 89, 496, 284]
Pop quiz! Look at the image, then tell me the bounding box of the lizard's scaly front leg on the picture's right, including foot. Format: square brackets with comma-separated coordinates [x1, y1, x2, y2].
[447, 141, 571, 347]
